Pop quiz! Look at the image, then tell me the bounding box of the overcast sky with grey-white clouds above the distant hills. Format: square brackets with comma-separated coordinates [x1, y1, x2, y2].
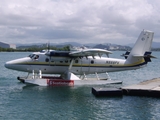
[0, 0, 160, 45]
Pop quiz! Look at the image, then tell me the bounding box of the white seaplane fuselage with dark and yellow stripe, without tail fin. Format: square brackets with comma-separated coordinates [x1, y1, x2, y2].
[5, 52, 144, 75]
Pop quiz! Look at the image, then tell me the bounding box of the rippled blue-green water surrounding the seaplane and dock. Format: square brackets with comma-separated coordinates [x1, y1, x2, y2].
[0, 52, 160, 120]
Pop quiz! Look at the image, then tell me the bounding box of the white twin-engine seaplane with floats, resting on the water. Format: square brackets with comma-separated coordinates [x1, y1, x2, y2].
[5, 30, 154, 86]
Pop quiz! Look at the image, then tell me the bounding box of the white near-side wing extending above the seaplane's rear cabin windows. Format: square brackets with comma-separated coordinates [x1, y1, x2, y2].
[69, 49, 112, 57]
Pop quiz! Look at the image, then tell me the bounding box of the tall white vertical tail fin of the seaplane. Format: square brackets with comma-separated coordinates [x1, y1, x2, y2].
[126, 30, 154, 64]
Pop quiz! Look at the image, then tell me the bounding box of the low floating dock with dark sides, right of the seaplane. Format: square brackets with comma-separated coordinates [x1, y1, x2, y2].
[92, 78, 160, 97]
